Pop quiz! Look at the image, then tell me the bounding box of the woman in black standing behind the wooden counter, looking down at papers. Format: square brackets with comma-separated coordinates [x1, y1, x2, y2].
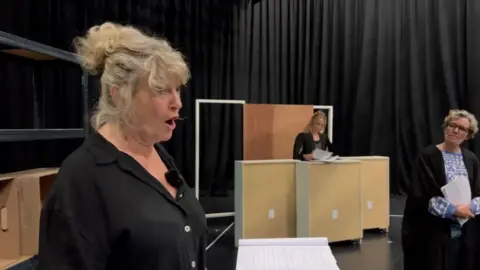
[293, 111, 335, 161]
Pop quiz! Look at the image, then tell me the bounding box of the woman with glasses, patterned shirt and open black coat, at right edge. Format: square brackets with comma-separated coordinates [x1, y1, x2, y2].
[402, 110, 480, 270]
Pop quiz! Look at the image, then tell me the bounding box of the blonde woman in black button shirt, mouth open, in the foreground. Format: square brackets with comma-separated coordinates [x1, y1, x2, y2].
[38, 23, 207, 270]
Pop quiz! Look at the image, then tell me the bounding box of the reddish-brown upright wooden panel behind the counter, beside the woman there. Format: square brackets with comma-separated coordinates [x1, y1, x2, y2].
[243, 104, 313, 160]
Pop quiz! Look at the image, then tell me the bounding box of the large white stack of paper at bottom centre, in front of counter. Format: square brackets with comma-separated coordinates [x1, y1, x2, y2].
[236, 238, 339, 270]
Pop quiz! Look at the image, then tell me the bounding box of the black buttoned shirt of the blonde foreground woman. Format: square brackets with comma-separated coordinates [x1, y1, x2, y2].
[38, 134, 207, 270]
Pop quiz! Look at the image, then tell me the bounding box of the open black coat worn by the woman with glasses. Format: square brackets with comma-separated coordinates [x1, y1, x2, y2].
[402, 145, 480, 270]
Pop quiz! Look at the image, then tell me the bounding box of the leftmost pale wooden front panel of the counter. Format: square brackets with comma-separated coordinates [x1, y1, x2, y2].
[242, 162, 296, 239]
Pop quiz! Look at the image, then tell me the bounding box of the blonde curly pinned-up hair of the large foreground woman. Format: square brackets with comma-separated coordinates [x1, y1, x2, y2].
[74, 22, 190, 129]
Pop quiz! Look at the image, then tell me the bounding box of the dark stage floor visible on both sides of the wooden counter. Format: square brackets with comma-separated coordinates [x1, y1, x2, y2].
[202, 197, 404, 270]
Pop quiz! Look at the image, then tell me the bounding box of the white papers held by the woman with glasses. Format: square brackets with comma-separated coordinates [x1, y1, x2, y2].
[441, 176, 472, 225]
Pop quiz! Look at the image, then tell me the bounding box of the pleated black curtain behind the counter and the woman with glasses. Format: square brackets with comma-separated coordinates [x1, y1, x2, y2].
[239, 0, 480, 193]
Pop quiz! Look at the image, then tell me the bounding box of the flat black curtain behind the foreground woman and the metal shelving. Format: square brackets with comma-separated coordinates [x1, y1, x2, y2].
[0, 0, 242, 198]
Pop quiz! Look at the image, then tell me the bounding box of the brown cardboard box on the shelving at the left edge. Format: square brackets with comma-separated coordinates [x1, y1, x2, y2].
[0, 168, 58, 259]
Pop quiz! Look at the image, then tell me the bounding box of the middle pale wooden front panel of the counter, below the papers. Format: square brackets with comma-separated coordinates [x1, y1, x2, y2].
[309, 162, 363, 242]
